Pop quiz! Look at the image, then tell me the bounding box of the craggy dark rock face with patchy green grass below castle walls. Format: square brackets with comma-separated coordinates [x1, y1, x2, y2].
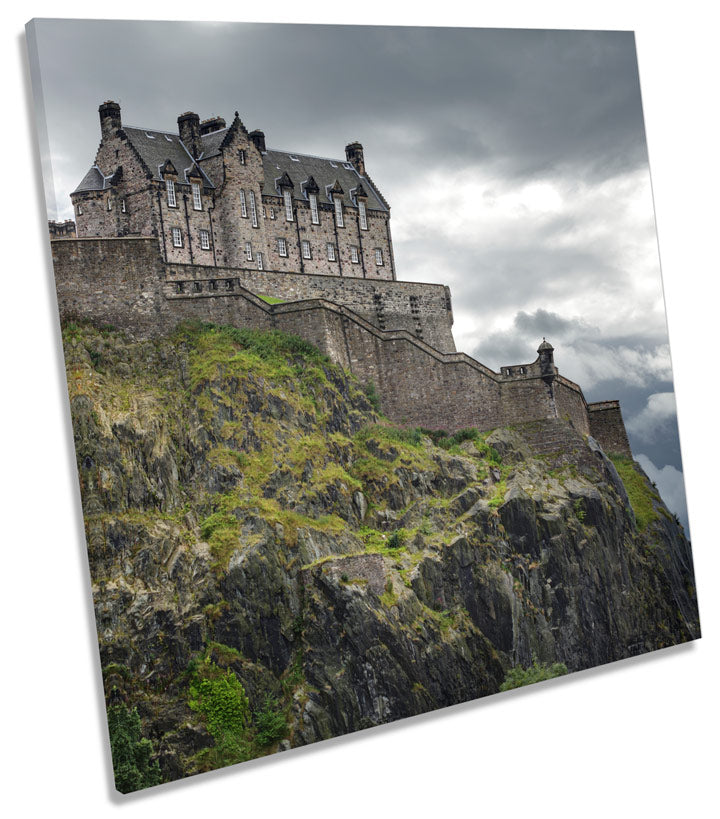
[64, 326, 700, 779]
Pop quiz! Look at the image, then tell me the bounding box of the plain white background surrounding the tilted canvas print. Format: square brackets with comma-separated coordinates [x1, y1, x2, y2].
[0, 0, 720, 819]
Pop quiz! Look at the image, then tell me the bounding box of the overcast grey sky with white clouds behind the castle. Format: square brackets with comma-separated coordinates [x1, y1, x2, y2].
[28, 20, 687, 526]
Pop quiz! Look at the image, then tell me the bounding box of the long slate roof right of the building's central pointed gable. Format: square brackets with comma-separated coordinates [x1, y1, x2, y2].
[262, 149, 388, 211]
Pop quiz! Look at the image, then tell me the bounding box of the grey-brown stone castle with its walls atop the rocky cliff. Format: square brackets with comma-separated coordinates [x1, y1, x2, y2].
[51, 102, 631, 455]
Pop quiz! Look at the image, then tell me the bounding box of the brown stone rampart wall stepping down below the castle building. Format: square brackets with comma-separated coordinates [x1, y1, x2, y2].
[52, 237, 630, 454]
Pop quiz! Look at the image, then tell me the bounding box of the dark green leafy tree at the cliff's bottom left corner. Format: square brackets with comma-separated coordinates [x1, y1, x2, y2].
[107, 703, 162, 793]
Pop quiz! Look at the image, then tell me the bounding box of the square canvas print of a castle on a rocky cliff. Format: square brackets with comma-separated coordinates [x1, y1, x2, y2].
[28, 20, 700, 793]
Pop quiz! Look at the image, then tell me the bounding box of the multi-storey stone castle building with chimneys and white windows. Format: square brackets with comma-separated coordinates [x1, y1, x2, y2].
[71, 102, 396, 281]
